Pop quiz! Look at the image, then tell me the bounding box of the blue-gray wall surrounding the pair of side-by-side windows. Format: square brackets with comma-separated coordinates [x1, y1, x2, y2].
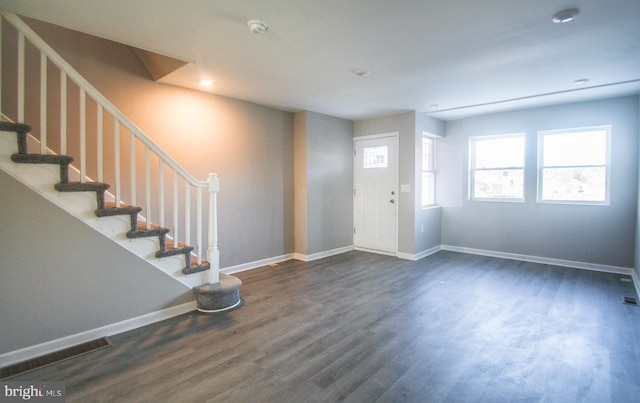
[437, 97, 638, 267]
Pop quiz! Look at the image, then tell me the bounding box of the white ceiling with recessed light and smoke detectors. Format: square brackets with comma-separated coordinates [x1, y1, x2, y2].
[0, 0, 640, 120]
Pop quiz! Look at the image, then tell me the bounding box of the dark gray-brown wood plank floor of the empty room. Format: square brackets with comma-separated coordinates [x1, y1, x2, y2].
[12, 251, 640, 402]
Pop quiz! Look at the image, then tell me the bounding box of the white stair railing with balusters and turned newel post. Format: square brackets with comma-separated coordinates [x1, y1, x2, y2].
[0, 12, 220, 283]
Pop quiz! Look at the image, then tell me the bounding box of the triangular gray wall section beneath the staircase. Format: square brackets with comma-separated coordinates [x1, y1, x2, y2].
[0, 171, 193, 354]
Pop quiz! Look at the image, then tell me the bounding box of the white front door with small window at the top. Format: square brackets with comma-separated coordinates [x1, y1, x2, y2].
[353, 133, 398, 254]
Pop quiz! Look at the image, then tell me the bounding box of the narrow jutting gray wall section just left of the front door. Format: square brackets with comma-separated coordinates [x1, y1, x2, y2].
[294, 111, 353, 256]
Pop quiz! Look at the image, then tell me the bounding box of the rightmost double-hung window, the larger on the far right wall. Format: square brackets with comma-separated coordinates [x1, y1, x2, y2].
[538, 126, 611, 204]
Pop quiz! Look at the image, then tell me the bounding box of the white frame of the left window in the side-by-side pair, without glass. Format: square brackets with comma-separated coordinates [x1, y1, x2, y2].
[468, 133, 527, 203]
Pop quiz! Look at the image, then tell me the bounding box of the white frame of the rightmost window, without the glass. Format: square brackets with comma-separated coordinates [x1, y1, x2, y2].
[537, 125, 611, 206]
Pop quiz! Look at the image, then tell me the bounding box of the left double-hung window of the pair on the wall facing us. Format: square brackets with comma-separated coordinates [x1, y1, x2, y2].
[469, 133, 525, 201]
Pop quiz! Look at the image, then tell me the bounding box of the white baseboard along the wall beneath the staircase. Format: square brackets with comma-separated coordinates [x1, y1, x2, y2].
[0, 301, 197, 367]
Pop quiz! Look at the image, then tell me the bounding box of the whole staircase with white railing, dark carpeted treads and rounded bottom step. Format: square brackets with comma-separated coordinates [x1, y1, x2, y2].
[0, 13, 241, 312]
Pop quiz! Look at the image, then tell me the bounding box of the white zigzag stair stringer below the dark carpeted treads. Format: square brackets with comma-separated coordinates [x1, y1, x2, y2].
[0, 131, 208, 288]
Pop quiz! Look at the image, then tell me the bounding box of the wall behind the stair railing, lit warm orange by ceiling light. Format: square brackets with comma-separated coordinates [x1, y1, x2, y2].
[18, 20, 294, 269]
